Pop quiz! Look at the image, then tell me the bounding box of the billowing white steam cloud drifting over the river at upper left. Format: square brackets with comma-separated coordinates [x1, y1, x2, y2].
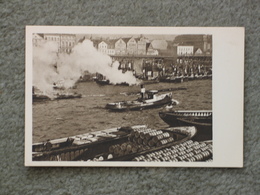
[33, 40, 137, 94]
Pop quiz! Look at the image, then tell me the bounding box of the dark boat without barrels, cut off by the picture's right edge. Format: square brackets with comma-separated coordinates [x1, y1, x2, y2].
[159, 110, 212, 141]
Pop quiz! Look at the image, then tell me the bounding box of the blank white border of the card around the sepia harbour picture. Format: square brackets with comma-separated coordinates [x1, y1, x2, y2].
[25, 26, 245, 168]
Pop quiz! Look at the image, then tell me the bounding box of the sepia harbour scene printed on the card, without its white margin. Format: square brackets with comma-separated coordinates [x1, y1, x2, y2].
[27, 25, 245, 166]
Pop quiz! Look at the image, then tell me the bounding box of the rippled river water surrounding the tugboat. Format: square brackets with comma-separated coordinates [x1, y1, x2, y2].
[33, 80, 212, 143]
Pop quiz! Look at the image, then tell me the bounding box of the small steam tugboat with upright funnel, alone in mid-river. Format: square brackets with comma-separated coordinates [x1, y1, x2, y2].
[105, 90, 173, 111]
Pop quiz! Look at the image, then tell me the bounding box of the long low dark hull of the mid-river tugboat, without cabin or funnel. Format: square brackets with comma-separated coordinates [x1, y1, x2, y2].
[106, 97, 172, 111]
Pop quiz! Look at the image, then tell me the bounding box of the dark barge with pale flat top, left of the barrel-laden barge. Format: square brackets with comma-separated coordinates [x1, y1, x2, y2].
[32, 125, 132, 161]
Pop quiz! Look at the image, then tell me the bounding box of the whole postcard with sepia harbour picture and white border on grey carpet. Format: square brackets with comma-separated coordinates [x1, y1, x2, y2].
[25, 26, 245, 168]
